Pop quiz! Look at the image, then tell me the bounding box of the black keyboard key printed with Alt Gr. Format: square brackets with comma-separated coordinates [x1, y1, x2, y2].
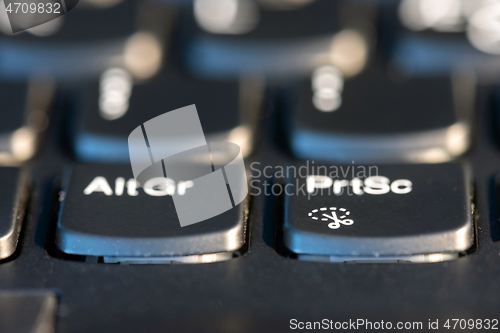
[56, 165, 247, 263]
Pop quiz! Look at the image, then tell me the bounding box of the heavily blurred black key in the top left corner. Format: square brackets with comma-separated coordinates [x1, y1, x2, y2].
[0, 0, 172, 80]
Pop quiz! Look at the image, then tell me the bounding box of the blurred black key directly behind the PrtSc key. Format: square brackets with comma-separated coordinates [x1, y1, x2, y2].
[285, 67, 475, 163]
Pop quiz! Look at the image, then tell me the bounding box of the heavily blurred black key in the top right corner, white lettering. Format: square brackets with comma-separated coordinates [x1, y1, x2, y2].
[381, 0, 500, 77]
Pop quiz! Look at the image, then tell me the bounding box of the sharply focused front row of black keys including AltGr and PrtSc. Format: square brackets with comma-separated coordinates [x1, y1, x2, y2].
[0, 162, 474, 264]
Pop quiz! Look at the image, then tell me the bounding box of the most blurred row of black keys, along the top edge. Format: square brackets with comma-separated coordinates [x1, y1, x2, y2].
[4, 0, 500, 79]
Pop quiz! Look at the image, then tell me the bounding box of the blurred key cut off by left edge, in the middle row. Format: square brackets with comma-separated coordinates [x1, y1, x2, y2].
[0, 80, 54, 165]
